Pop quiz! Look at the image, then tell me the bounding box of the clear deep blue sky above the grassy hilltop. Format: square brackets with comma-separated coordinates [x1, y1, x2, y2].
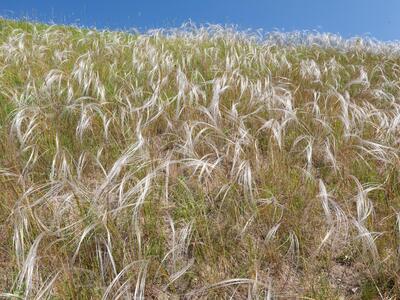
[0, 0, 400, 40]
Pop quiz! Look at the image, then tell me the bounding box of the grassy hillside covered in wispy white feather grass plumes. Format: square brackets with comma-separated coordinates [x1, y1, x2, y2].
[0, 19, 400, 299]
